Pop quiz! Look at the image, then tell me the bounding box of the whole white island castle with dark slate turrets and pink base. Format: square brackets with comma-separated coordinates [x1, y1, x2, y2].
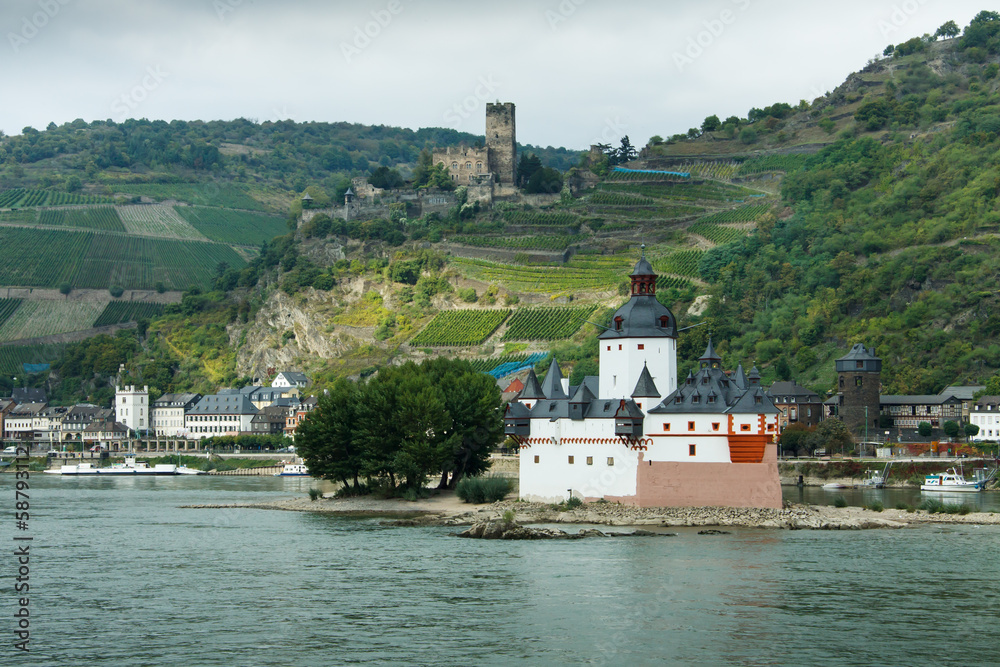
[505, 257, 781, 507]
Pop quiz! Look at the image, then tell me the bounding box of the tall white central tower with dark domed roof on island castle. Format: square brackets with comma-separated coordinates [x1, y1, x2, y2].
[598, 247, 677, 402]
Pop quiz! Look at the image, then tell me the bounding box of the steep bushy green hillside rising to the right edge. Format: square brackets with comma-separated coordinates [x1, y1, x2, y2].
[647, 12, 1000, 394]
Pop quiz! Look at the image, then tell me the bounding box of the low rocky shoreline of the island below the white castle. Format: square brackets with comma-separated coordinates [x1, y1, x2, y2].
[185, 494, 1000, 530]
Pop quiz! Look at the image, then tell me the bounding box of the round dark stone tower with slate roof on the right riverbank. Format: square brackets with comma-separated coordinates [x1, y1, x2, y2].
[836, 343, 882, 437]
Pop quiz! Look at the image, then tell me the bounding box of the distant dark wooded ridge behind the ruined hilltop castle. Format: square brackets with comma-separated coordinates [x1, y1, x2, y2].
[0, 118, 579, 193]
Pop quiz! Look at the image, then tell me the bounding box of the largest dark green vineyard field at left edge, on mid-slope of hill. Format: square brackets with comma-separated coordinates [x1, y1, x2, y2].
[0, 227, 246, 290]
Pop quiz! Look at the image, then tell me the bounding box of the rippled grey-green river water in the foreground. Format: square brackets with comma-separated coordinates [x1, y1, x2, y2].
[0, 474, 1000, 666]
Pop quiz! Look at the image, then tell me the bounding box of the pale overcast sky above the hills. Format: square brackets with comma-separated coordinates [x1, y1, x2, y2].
[0, 0, 988, 148]
